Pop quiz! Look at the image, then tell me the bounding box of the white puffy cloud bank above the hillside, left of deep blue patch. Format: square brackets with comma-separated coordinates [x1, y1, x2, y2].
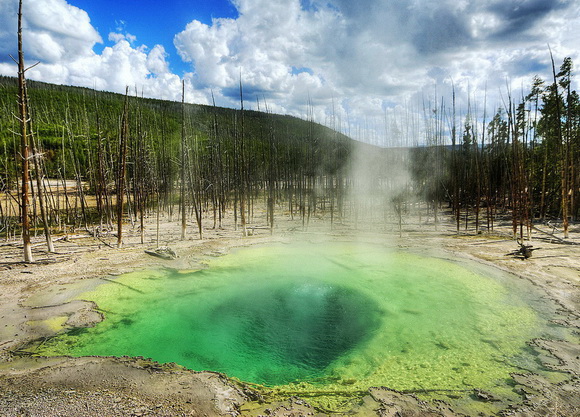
[0, 0, 207, 103]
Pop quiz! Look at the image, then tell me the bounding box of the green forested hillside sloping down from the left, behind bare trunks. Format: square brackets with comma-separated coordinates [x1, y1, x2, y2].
[0, 77, 362, 244]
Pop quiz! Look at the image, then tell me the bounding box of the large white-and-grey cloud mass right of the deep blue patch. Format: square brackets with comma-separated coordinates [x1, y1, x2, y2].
[174, 0, 579, 120]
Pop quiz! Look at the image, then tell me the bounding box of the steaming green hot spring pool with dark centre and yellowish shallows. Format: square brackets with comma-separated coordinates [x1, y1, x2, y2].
[38, 243, 555, 411]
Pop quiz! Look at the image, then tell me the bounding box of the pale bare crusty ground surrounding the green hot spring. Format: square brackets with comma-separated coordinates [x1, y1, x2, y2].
[0, 208, 580, 417]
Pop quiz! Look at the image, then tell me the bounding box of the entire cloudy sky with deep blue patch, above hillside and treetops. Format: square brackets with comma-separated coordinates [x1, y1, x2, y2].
[0, 0, 580, 144]
